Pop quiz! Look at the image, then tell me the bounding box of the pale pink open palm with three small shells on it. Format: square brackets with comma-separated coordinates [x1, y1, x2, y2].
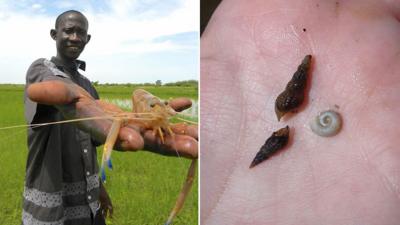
[201, 0, 400, 225]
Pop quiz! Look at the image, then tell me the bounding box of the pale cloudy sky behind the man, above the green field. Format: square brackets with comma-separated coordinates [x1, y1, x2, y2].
[0, 0, 200, 83]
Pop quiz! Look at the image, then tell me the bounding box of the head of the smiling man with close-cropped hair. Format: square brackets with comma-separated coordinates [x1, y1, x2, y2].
[50, 10, 90, 61]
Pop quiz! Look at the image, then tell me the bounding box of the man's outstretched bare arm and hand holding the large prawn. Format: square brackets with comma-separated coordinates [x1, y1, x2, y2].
[27, 80, 198, 158]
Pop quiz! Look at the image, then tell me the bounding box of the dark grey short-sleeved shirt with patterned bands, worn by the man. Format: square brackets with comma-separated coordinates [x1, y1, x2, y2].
[22, 57, 100, 225]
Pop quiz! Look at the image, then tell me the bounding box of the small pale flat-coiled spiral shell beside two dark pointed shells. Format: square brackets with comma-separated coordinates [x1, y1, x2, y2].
[310, 110, 342, 137]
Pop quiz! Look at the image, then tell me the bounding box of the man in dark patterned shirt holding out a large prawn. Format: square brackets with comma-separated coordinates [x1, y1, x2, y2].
[22, 10, 197, 225]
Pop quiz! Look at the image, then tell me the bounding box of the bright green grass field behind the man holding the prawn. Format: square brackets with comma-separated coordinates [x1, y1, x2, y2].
[0, 85, 198, 225]
